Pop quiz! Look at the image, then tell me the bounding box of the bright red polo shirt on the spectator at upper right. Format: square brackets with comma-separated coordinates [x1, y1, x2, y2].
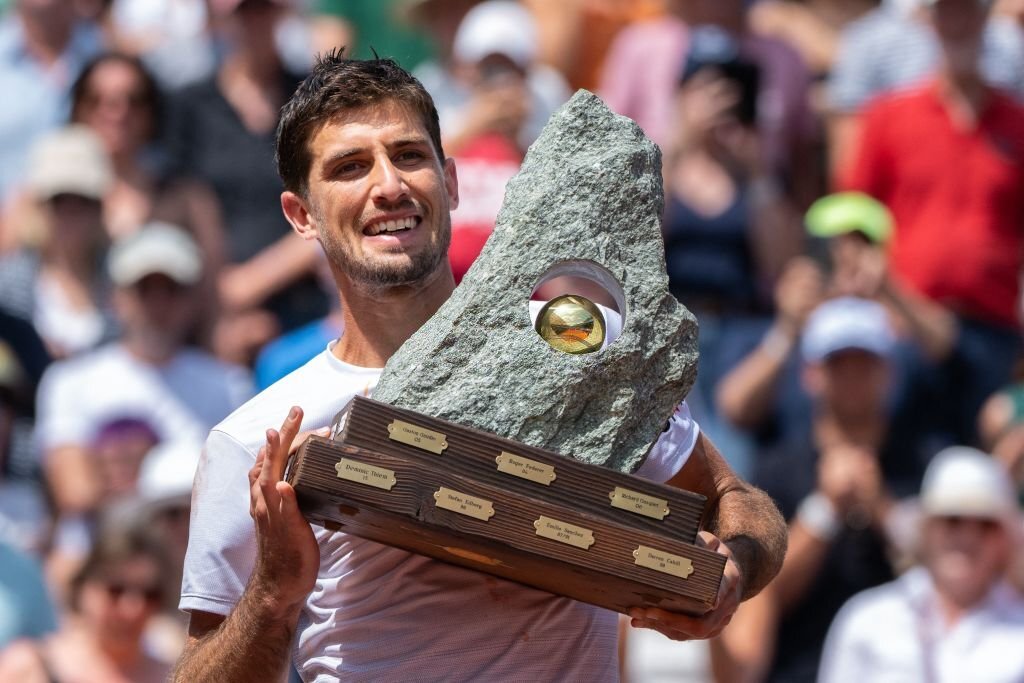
[841, 82, 1024, 326]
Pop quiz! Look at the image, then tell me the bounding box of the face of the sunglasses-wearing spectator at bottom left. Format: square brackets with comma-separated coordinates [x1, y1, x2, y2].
[78, 555, 164, 641]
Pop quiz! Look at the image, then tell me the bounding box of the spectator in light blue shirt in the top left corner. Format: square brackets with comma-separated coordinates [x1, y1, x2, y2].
[0, 0, 100, 214]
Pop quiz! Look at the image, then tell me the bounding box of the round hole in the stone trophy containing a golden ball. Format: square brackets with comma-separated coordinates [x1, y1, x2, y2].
[529, 259, 627, 354]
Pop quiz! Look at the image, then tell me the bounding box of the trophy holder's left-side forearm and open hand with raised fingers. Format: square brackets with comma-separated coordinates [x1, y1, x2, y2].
[172, 408, 319, 683]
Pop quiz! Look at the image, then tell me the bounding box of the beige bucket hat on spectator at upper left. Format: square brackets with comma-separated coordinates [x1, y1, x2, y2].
[26, 125, 114, 200]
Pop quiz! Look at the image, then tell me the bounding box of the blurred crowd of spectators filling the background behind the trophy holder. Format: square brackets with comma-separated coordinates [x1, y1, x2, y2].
[0, 0, 1024, 682]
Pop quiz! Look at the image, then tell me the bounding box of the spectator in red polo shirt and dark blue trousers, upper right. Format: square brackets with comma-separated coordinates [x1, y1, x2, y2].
[843, 0, 1024, 443]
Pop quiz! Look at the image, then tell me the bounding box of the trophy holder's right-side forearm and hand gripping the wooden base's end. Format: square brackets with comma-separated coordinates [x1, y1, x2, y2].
[630, 433, 786, 640]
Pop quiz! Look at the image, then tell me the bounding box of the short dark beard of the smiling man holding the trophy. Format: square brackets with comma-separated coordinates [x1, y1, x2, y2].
[317, 211, 452, 289]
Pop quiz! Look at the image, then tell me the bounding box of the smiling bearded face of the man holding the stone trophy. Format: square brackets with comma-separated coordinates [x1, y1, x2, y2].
[286, 101, 459, 288]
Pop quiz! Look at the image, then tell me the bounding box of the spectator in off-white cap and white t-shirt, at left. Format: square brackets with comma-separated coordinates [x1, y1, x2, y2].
[37, 223, 252, 554]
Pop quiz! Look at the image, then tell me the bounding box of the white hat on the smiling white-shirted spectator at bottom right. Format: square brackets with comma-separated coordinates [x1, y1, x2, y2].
[921, 445, 1019, 521]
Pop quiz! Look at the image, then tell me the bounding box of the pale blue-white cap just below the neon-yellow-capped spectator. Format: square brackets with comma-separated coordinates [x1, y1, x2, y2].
[801, 297, 896, 362]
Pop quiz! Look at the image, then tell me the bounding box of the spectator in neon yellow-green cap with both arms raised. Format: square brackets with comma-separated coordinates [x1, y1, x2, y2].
[715, 193, 956, 447]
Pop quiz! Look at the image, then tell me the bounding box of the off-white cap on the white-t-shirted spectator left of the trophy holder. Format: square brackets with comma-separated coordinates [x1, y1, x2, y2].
[108, 222, 203, 287]
